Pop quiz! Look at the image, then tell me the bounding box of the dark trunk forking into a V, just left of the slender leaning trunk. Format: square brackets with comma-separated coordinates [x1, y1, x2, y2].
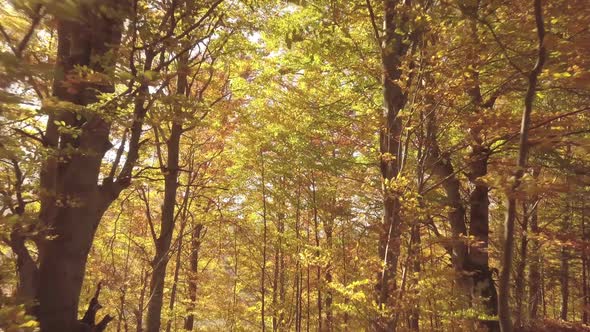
[426, 85, 498, 331]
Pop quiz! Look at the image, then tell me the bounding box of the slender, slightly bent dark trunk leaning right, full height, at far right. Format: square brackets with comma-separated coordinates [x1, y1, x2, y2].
[498, 0, 546, 332]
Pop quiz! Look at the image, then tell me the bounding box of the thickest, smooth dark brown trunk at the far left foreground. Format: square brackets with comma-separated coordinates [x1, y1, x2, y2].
[36, 0, 133, 332]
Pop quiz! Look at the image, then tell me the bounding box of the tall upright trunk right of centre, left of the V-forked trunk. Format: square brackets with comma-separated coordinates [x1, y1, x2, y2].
[380, 0, 409, 331]
